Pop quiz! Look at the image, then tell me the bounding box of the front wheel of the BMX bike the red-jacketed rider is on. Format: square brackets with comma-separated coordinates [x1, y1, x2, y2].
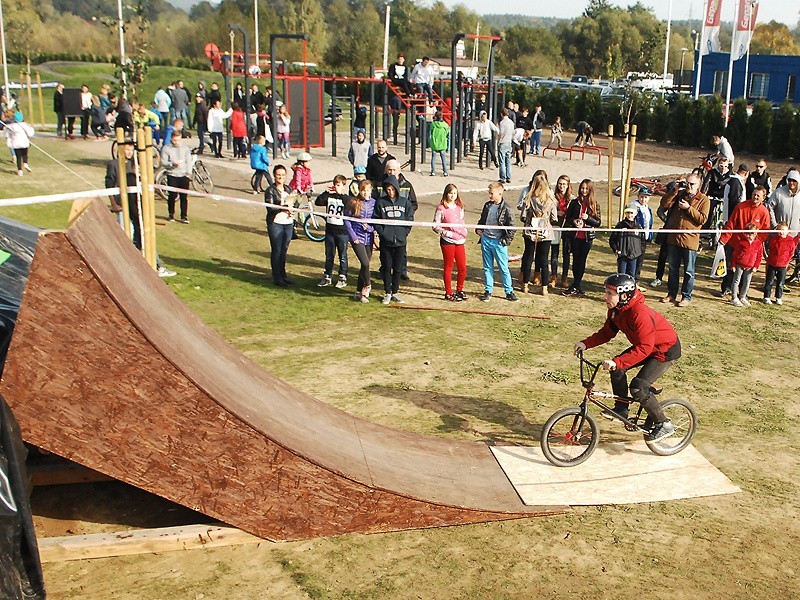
[540, 406, 600, 467]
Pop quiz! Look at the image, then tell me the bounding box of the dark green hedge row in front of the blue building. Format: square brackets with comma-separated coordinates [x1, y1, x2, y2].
[506, 86, 800, 159]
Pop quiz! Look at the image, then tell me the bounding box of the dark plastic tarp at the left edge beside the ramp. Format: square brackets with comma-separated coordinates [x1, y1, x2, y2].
[0, 217, 45, 600]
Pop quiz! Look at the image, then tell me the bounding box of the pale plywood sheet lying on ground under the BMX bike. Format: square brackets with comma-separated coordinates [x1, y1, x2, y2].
[492, 440, 741, 506]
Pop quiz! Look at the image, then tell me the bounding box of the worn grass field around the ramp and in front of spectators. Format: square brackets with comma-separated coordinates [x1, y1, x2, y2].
[0, 134, 800, 600]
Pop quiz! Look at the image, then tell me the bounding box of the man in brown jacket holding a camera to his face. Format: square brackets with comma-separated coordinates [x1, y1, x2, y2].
[661, 173, 710, 308]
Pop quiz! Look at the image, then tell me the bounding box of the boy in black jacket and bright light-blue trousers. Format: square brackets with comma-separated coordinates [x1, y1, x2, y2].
[476, 181, 519, 302]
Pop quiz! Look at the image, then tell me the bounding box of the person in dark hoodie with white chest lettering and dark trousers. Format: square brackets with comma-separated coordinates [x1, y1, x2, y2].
[373, 175, 414, 304]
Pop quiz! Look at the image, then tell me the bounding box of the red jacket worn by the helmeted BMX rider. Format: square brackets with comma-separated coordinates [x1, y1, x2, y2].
[583, 290, 678, 369]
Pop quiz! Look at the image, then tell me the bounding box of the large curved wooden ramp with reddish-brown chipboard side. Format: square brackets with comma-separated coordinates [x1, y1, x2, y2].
[0, 200, 565, 540]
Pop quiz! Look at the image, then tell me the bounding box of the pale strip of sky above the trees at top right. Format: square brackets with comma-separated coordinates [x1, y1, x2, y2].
[444, 0, 800, 28]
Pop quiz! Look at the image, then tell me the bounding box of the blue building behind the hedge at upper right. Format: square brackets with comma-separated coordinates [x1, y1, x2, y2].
[692, 52, 800, 104]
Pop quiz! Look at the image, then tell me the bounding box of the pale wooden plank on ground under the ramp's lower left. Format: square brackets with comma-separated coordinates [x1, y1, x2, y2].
[38, 524, 266, 563]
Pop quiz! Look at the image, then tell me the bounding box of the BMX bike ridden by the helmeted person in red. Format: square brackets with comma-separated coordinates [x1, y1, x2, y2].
[540, 351, 697, 467]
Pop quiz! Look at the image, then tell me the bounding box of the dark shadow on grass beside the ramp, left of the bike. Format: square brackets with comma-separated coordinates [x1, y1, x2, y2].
[366, 385, 542, 445]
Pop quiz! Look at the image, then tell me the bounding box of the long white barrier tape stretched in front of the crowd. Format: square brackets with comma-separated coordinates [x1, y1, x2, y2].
[0, 185, 800, 235]
